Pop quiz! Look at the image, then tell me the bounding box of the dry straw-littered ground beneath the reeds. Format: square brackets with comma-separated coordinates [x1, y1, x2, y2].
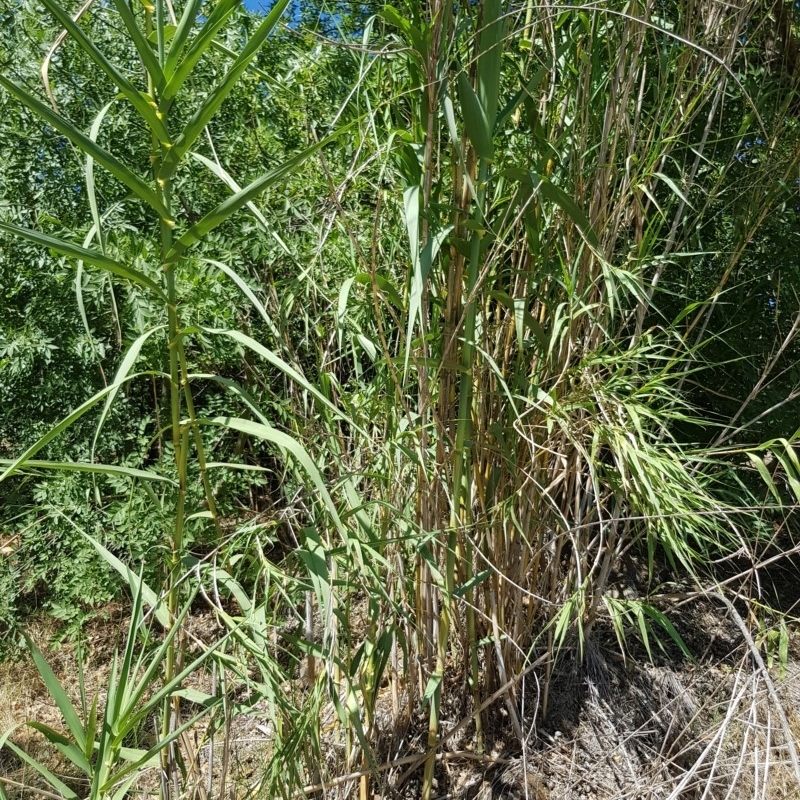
[0, 575, 800, 800]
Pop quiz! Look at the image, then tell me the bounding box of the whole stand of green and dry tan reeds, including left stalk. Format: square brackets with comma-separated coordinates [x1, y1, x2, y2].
[0, 0, 800, 800]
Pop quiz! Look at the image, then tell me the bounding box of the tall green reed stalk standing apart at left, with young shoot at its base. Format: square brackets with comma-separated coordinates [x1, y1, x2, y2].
[0, 0, 360, 800]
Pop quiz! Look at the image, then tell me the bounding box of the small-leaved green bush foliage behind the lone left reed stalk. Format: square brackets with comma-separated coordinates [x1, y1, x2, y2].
[0, 4, 356, 632]
